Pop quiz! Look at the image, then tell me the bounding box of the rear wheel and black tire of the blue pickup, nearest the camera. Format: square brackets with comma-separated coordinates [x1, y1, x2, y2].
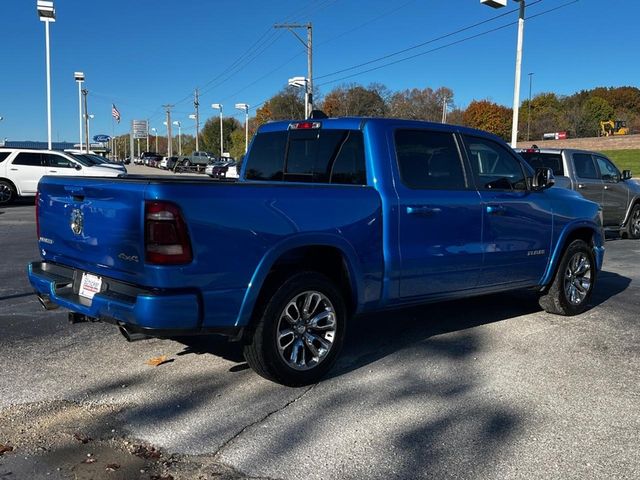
[244, 272, 347, 387]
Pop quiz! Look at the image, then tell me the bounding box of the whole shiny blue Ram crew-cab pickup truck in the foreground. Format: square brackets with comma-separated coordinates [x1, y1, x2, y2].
[28, 118, 604, 385]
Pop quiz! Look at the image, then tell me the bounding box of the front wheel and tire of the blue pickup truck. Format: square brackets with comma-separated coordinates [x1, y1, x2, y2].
[539, 240, 596, 316]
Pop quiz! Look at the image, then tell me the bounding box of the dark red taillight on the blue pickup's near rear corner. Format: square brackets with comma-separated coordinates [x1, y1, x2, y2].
[144, 201, 193, 265]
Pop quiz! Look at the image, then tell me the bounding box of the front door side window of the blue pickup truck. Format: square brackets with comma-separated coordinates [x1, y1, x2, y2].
[464, 135, 527, 190]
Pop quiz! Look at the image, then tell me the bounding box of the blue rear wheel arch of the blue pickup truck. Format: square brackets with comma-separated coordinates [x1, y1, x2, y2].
[236, 235, 363, 326]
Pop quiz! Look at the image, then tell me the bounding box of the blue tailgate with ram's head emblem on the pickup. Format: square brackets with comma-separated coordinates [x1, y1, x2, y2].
[38, 177, 146, 281]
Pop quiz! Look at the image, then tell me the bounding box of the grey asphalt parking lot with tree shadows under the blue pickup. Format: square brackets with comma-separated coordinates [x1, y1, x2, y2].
[0, 196, 640, 479]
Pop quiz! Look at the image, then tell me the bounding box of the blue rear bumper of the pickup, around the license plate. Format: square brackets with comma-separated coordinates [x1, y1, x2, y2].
[28, 262, 237, 337]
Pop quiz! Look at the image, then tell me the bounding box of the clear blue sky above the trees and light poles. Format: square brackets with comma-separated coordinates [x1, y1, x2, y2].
[0, 0, 640, 141]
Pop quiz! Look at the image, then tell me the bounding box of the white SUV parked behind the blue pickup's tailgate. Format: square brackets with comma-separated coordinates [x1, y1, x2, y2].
[0, 148, 122, 205]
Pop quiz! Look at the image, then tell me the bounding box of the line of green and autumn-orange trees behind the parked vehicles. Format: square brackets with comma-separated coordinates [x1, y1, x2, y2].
[116, 83, 640, 159]
